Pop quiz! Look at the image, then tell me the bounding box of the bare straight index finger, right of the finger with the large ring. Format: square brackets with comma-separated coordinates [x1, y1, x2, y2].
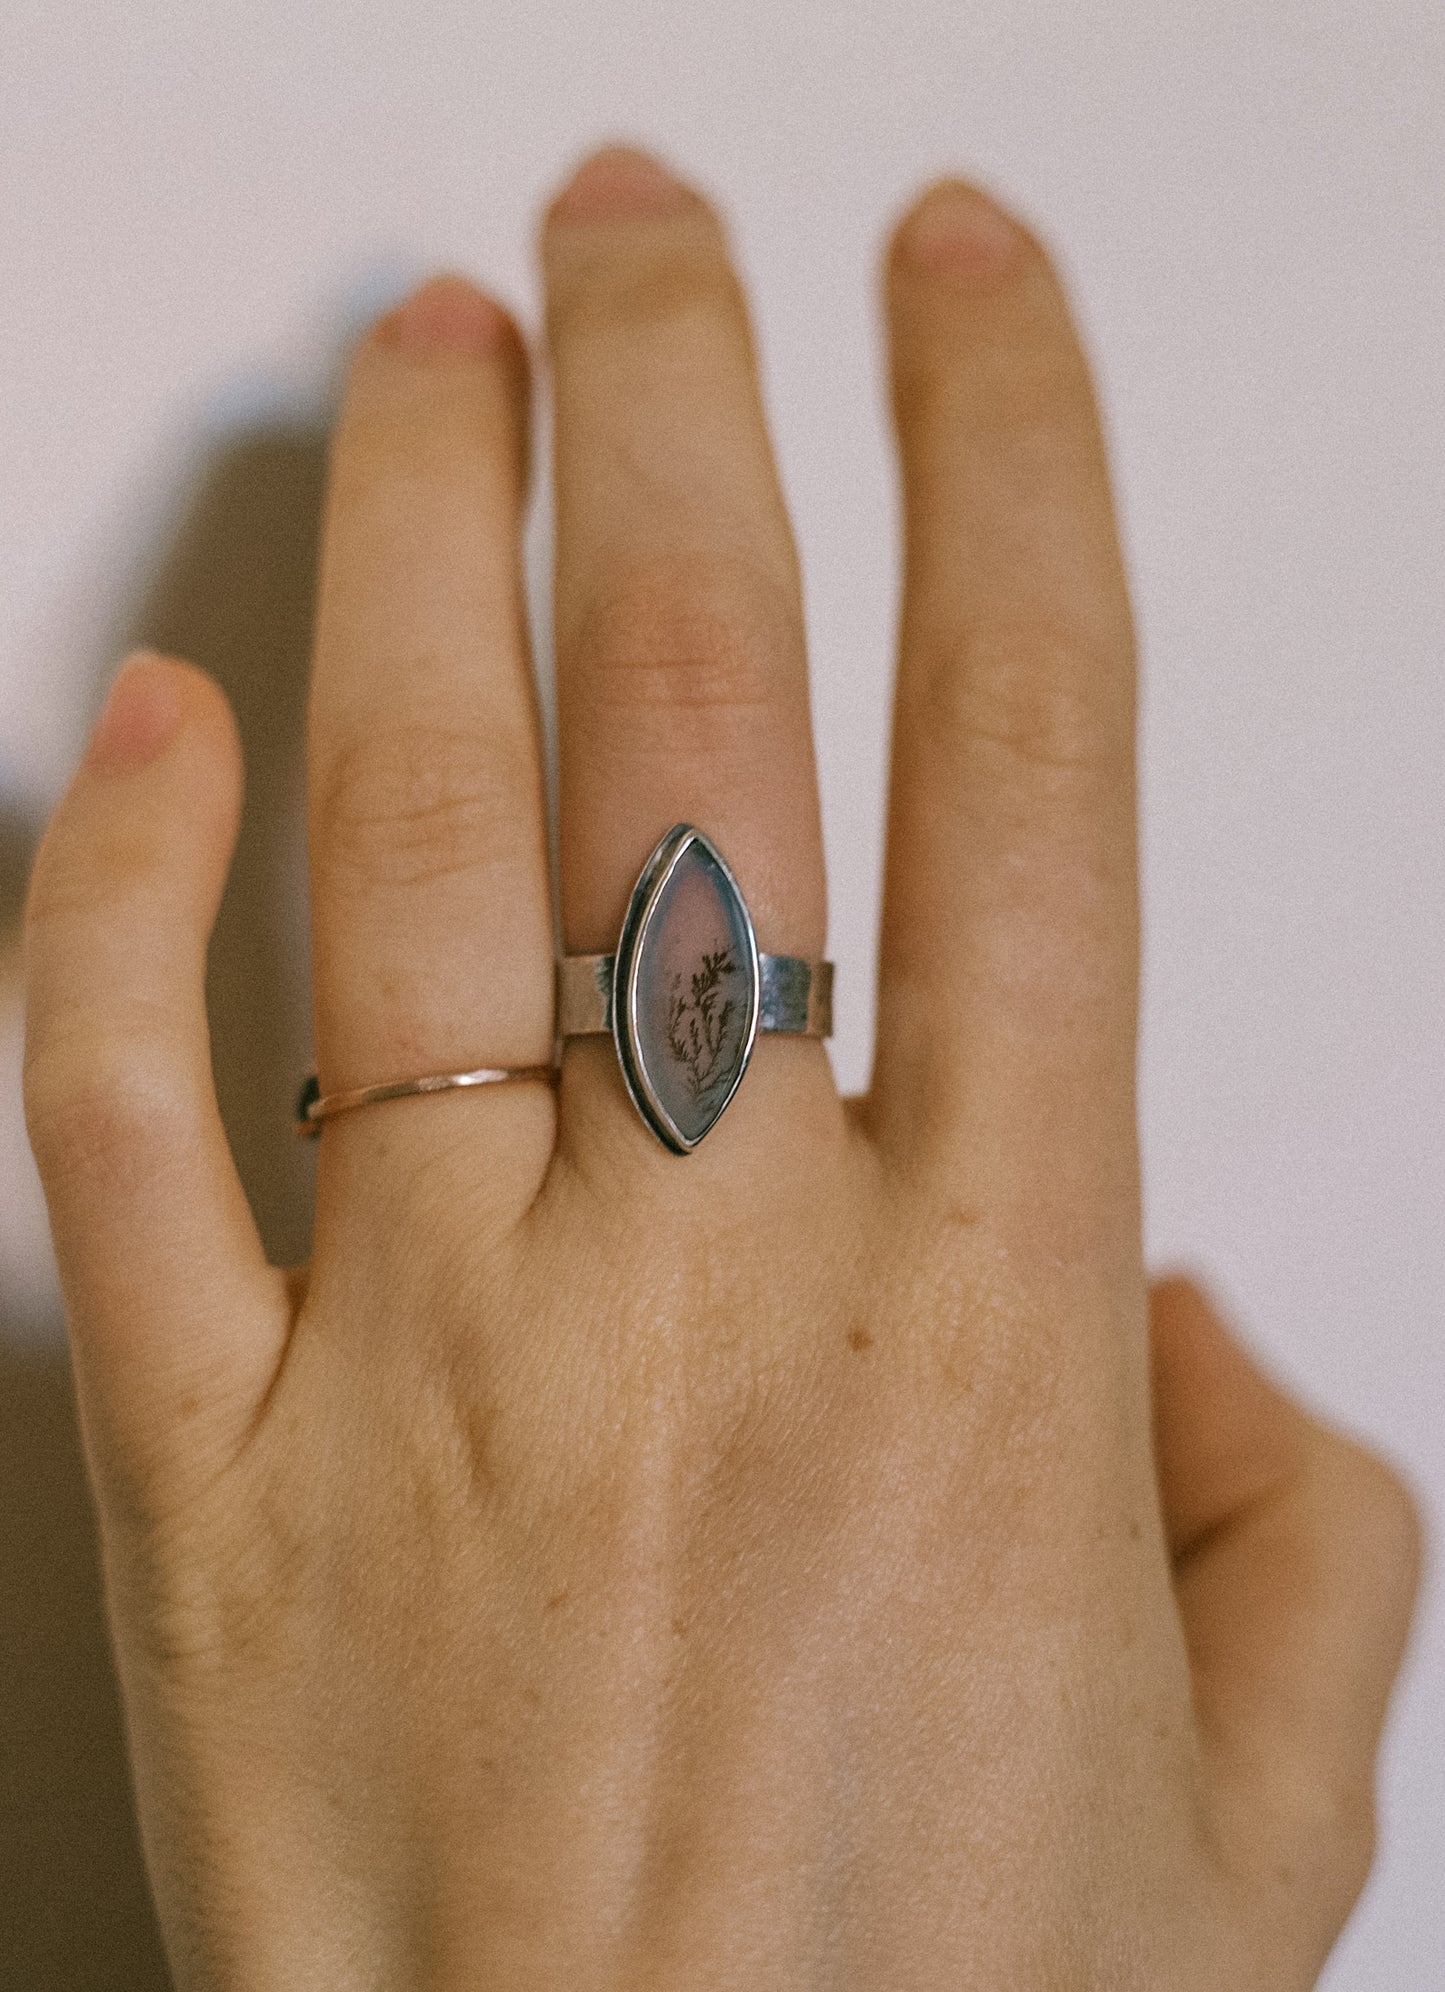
[873, 183, 1136, 1209]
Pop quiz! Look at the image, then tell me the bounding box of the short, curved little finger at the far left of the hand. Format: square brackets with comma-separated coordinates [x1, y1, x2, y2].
[26, 657, 287, 1497]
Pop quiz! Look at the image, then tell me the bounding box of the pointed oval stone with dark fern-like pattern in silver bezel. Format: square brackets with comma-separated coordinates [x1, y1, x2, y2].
[612, 823, 759, 1155]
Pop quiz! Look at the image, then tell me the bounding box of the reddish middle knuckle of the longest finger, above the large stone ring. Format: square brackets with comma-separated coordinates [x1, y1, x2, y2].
[570, 556, 801, 717]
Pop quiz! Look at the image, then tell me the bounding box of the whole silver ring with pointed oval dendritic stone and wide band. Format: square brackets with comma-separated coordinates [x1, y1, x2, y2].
[558, 823, 833, 1155]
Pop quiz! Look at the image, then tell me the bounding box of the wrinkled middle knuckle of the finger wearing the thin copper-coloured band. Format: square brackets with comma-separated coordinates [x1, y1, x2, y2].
[315, 721, 530, 890]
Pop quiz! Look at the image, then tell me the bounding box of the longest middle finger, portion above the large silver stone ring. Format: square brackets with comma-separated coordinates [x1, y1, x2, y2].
[544, 149, 825, 1155]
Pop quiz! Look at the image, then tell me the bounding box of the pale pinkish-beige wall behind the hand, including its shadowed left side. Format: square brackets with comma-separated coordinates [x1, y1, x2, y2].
[0, 0, 1445, 1992]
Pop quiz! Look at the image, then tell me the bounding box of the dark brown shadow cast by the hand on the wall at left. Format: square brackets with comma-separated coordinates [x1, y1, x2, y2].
[0, 426, 325, 1992]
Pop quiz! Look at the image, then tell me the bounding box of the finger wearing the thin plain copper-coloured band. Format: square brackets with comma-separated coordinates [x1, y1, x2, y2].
[309, 277, 552, 1141]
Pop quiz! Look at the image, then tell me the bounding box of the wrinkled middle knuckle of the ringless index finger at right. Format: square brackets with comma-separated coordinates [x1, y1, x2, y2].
[919, 620, 1132, 785]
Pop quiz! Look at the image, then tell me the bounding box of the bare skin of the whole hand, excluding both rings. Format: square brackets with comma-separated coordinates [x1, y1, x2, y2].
[26, 149, 1417, 1992]
